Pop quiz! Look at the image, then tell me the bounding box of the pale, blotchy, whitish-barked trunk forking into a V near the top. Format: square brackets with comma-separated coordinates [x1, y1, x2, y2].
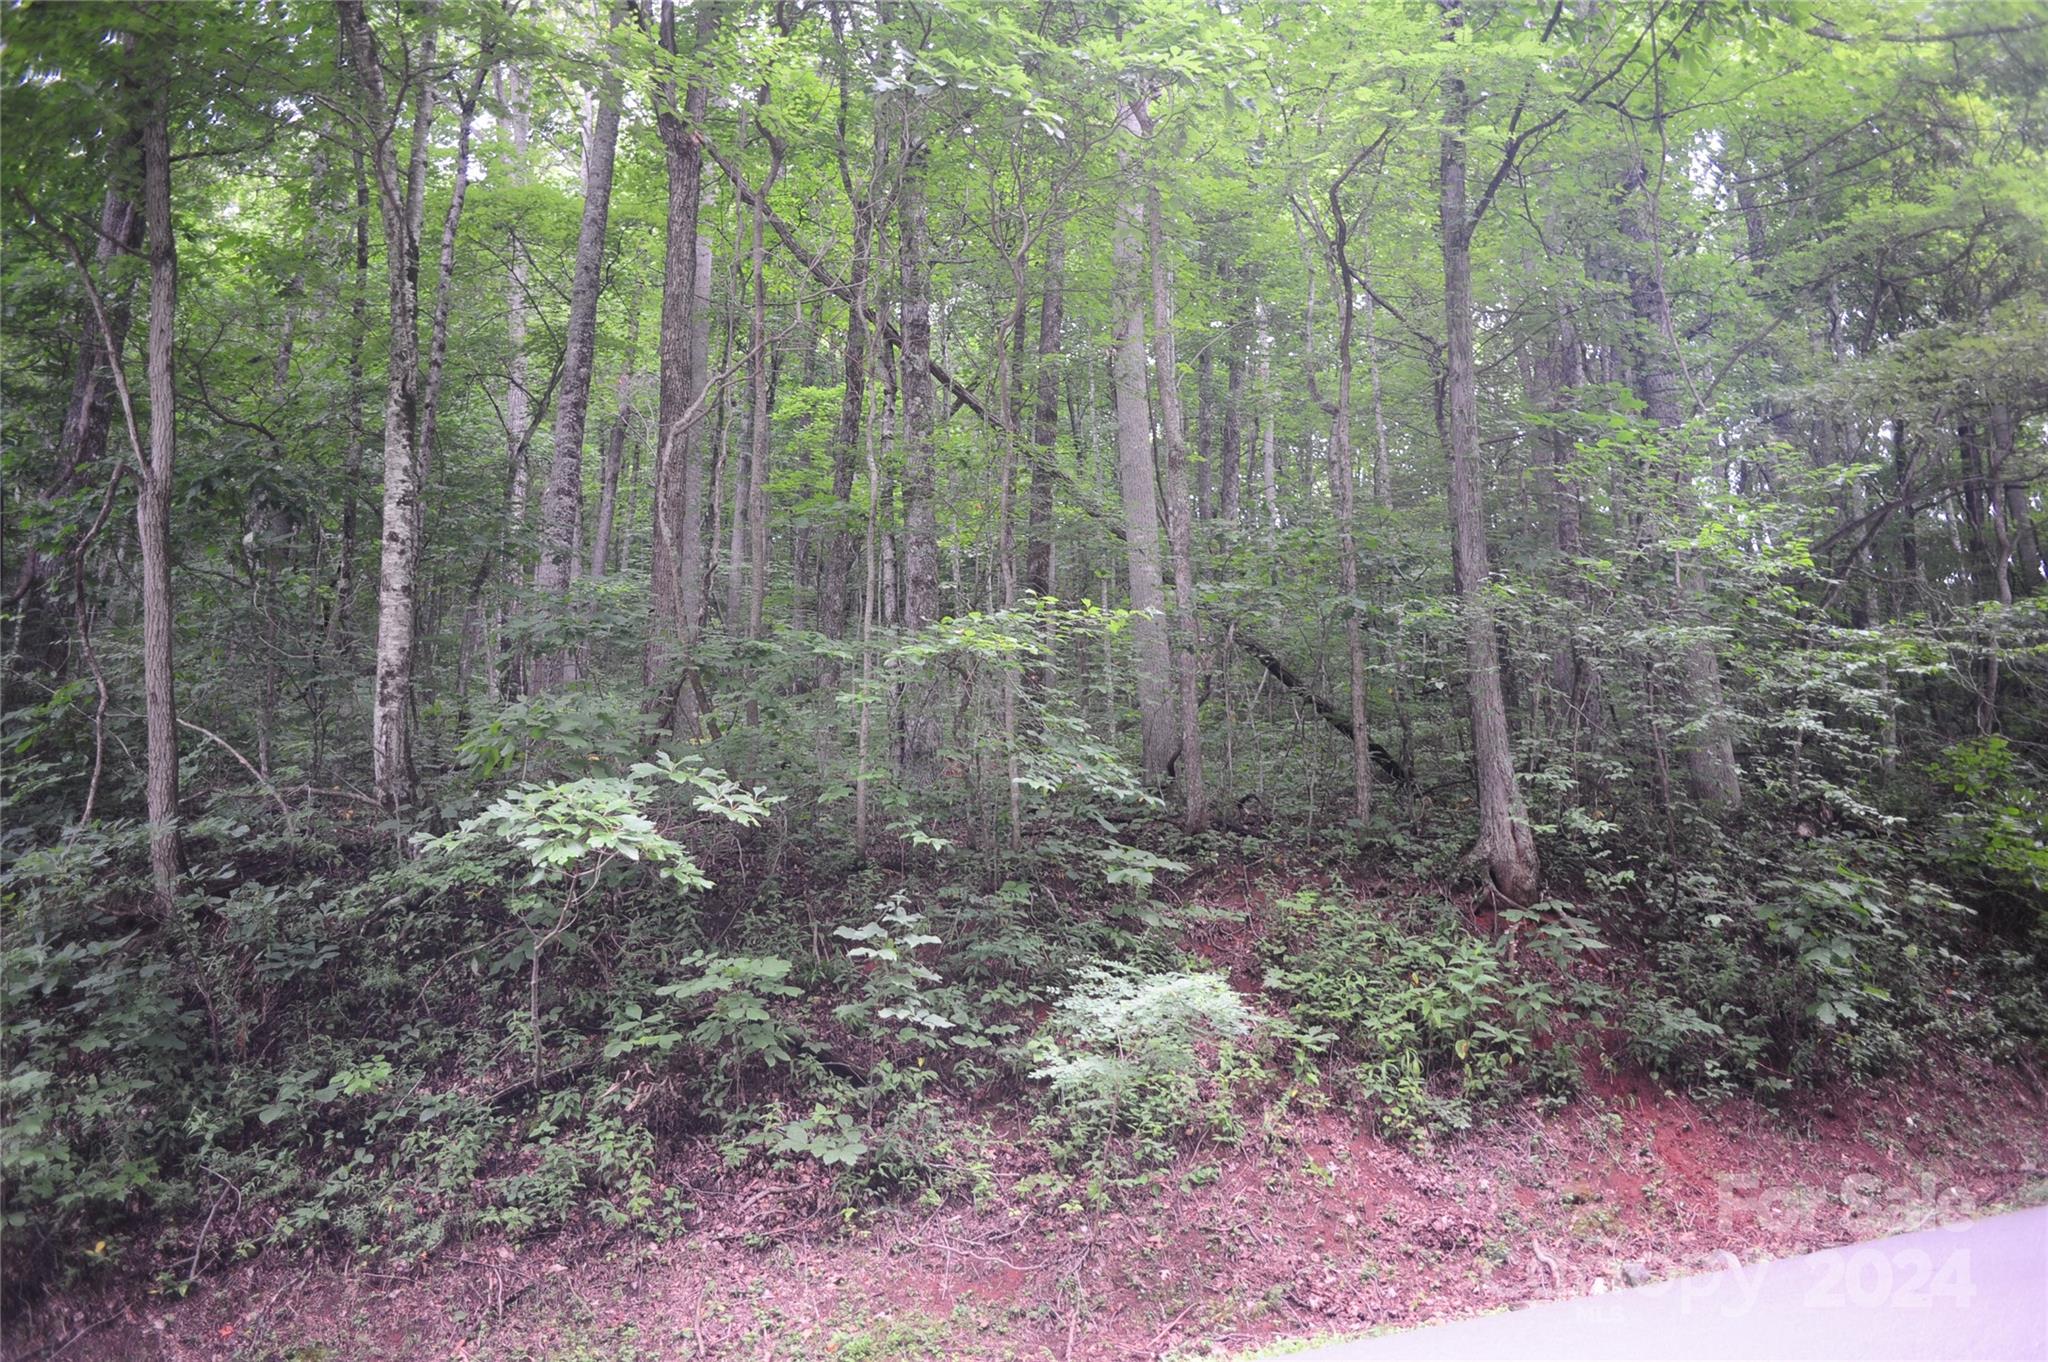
[334, 0, 434, 811]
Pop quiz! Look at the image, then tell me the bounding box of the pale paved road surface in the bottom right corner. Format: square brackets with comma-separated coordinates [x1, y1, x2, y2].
[1292, 1206, 2048, 1362]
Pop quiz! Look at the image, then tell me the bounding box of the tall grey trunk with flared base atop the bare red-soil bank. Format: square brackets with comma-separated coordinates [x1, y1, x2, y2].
[1438, 10, 1542, 903]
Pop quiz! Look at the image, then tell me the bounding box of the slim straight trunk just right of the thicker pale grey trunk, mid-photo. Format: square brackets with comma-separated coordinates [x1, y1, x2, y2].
[1145, 178, 1208, 832]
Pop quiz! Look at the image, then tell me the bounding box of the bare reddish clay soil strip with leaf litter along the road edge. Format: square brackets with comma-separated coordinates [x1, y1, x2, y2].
[19, 1065, 2048, 1362]
